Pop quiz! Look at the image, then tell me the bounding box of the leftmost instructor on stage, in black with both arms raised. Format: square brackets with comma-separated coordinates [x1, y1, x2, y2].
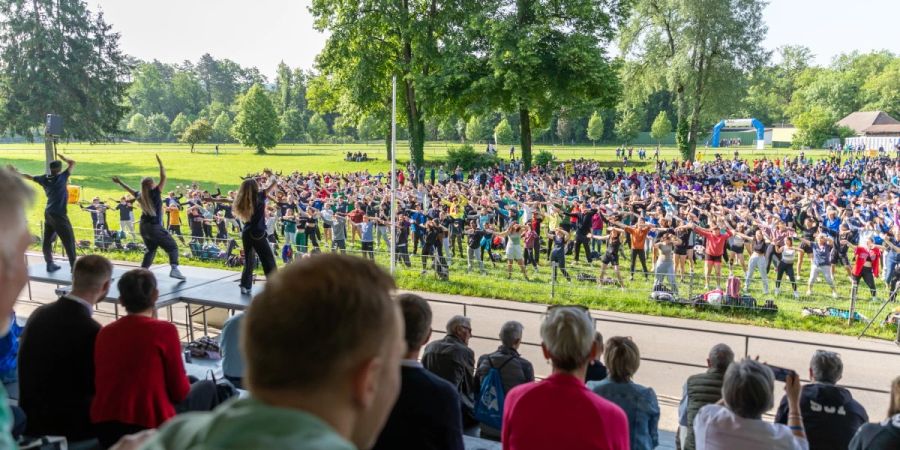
[8, 155, 76, 272]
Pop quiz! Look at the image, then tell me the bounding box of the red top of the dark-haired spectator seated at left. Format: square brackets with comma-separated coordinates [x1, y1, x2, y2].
[91, 315, 191, 428]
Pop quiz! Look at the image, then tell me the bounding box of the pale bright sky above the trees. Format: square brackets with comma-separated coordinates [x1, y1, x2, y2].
[87, 0, 900, 80]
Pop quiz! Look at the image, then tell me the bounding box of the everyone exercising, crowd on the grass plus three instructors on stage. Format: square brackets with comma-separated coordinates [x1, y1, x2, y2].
[14, 148, 900, 298]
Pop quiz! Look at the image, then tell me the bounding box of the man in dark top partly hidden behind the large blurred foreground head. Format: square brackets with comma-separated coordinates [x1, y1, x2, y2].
[373, 294, 464, 450]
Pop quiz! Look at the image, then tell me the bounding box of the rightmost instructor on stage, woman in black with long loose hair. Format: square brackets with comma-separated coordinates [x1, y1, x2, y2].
[232, 170, 276, 295]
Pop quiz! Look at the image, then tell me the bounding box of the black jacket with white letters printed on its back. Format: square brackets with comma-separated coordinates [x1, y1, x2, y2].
[775, 383, 869, 450]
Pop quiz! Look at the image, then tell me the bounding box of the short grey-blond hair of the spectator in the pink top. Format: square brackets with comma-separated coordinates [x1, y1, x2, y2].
[541, 307, 595, 371]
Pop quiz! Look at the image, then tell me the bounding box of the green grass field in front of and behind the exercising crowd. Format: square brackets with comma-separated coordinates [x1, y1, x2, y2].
[0, 143, 893, 338]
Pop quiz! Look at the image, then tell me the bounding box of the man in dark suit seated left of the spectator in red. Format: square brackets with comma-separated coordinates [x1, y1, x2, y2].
[19, 255, 112, 442]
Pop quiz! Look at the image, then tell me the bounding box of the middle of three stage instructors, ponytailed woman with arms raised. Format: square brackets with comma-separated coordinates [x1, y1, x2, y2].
[112, 155, 185, 280]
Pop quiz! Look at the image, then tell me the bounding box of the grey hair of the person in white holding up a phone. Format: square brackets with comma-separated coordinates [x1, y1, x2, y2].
[722, 358, 775, 419]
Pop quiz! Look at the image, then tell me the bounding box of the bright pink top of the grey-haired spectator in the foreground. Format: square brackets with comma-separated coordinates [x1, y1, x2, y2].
[503, 374, 630, 450]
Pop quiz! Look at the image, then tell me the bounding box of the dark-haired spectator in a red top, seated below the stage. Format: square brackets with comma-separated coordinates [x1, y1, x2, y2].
[91, 269, 216, 448]
